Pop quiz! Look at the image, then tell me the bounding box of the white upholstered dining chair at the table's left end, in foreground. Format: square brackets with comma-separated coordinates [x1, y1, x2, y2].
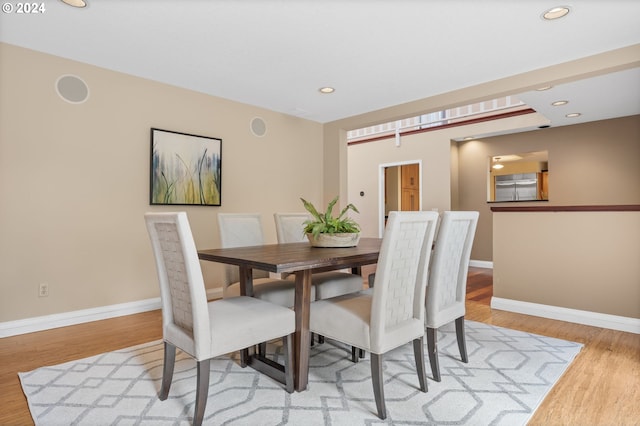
[145, 212, 295, 425]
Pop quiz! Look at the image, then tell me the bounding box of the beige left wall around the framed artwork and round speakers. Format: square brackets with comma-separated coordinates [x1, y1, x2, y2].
[0, 44, 324, 322]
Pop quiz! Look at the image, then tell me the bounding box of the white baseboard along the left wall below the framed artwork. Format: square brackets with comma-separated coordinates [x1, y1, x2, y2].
[0, 288, 222, 338]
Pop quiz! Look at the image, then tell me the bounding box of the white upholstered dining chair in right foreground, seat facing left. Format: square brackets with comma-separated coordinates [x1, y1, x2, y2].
[309, 211, 438, 419]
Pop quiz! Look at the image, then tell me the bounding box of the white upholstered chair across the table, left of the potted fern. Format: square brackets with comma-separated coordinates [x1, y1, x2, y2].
[218, 213, 308, 307]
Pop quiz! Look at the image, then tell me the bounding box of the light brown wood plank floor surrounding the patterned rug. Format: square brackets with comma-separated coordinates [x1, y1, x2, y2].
[0, 268, 640, 425]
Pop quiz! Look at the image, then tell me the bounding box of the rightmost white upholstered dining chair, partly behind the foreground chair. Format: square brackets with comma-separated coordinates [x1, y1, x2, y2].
[425, 211, 479, 382]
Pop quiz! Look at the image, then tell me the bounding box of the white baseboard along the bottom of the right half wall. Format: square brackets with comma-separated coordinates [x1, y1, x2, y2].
[491, 297, 640, 334]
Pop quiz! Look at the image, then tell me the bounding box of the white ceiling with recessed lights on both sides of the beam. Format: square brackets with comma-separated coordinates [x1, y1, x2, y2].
[0, 0, 640, 126]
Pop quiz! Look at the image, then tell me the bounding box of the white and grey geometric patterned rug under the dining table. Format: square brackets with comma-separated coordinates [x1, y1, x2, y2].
[19, 321, 582, 426]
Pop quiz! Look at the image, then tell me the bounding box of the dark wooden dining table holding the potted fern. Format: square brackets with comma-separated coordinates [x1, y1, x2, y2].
[198, 238, 382, 391]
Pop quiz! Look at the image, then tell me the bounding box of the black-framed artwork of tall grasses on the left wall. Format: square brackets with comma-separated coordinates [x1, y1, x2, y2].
[149, 128, 222, 206]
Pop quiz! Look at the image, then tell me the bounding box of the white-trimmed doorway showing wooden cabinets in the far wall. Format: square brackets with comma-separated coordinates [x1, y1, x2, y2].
[378, 160, 422, 237]
